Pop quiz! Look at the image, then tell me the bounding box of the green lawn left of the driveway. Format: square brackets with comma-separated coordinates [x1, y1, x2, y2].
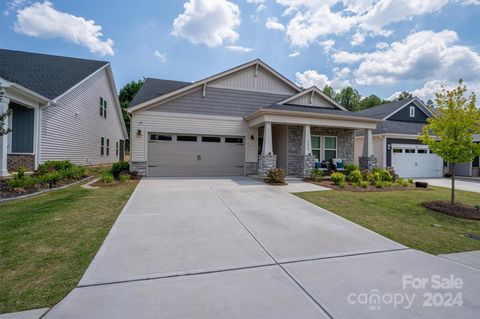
[0, 182, 136, 313]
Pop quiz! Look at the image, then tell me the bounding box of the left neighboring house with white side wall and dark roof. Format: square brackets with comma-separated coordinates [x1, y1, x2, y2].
[0, 49, 128, 176]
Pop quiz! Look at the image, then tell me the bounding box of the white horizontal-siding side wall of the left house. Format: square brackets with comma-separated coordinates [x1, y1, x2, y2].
[40, 69, 124, 165]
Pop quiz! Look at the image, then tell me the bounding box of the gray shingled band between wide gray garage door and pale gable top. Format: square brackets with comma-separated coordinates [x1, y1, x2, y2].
[150, 87, 288, 116]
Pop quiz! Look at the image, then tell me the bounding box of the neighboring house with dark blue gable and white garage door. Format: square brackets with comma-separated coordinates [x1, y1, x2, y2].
[355, 98, 480, 177]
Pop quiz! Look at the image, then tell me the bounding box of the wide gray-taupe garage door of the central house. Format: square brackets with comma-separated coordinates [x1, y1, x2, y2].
[148, 133, 245, 176]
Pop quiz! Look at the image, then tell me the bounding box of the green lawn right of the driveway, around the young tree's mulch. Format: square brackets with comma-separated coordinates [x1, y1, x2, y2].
[297, 187, 480, 254]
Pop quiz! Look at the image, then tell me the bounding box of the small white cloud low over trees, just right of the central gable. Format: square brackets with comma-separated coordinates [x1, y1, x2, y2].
[295, 67, 350, 90]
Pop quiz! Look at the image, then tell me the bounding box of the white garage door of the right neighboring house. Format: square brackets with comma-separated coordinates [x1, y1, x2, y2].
[391, 145, 443, 177]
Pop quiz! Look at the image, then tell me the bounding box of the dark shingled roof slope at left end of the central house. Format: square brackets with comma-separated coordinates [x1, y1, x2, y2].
[129, 78, 192, 107]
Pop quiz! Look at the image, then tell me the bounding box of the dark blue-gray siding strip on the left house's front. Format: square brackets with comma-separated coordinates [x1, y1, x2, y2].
[10, 103, 35, 153]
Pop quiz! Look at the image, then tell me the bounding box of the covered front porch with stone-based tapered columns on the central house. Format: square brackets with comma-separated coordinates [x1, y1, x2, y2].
[247, 111, 378, 177]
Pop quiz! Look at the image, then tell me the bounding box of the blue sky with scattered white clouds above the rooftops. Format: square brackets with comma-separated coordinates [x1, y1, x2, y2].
[0, 0, 480, 99]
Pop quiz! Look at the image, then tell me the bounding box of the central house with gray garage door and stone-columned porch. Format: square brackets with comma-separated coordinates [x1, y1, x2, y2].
[128, 59, 381, 176]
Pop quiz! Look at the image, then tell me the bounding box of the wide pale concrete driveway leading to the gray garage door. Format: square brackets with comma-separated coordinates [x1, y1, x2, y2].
[45, 178, 480, 318]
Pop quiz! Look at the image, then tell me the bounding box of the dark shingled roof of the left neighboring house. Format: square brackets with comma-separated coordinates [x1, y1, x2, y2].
[0, 49, 108, 99]
